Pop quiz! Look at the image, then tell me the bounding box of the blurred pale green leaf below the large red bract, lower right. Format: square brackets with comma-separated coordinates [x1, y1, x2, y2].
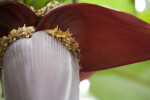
[90, 61, 150, 100]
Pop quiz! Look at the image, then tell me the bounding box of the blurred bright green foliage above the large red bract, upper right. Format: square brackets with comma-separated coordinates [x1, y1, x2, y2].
[79, 0, 150, 23]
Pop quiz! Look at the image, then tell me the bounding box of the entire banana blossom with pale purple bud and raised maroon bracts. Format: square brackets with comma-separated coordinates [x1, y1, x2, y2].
[0, 1, 150, 100]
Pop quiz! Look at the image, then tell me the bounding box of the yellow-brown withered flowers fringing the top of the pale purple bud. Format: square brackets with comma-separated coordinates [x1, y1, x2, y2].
[0, 25, 80, 68]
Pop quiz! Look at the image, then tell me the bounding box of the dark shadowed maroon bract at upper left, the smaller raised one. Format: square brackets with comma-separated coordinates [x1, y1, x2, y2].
[0, 1, 37, 37]
